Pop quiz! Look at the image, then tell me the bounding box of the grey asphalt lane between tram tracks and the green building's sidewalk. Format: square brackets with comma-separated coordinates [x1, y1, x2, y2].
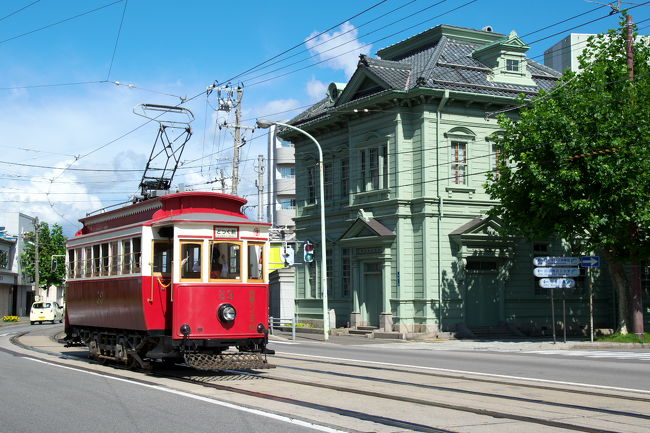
[270, 337, 650, 392]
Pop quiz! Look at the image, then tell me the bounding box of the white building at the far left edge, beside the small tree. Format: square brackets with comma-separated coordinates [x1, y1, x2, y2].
[0, 212, 35, 316]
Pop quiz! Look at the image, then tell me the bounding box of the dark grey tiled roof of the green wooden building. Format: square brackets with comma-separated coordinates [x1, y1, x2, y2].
[290, 26, 560, 123]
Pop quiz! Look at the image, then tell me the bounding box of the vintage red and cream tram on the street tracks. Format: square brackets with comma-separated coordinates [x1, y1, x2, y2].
[66, 192, 273, 369]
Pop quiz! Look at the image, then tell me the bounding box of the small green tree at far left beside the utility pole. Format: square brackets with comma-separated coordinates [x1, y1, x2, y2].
[20, 222, 66, 289]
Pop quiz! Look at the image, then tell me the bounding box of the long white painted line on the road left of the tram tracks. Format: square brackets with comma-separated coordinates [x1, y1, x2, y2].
[23, 356, 345, 433]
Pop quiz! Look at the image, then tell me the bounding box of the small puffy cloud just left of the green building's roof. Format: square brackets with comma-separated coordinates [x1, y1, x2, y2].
[305, 22, 371, 78]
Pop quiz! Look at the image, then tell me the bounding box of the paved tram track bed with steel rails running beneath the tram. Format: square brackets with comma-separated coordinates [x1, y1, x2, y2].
[11, 335, 650, 433]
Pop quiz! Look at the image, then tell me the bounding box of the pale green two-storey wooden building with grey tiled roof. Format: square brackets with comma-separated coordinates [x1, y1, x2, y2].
[280, 25, 613, 333]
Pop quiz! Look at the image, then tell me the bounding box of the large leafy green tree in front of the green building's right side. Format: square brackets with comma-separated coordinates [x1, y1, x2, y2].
[486, 15, 650, 333]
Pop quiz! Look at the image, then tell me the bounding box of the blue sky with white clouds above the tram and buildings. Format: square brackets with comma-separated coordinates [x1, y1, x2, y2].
[0, 0, 650, 235]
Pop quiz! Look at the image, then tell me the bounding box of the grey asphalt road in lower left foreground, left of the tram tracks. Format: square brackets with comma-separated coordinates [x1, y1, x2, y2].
[0, 325, 340, 433]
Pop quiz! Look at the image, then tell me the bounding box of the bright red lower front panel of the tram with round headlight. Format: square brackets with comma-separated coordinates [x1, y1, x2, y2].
[172, 283, 269, 339]
